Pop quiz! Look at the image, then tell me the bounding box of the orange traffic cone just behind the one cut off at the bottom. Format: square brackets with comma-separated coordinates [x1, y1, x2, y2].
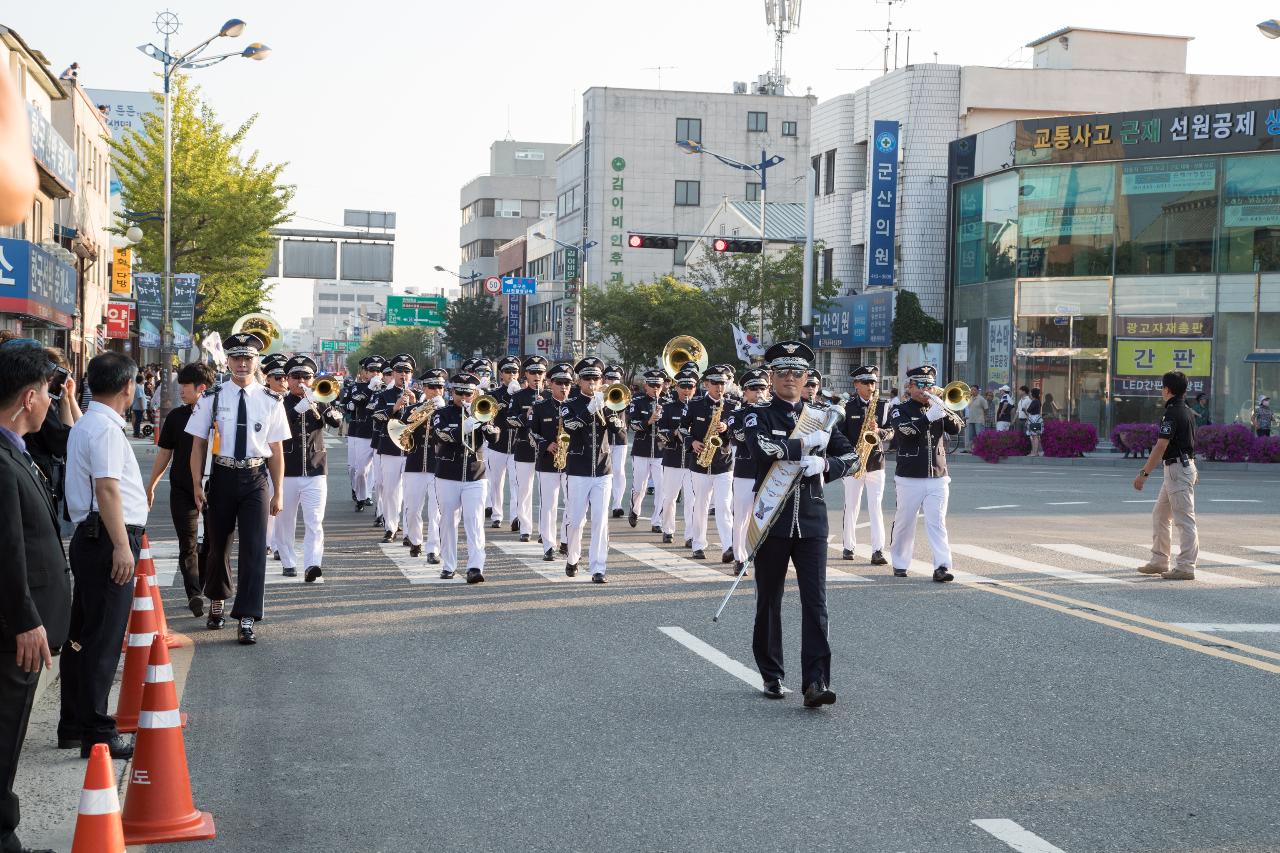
[123, 637, 215, 844]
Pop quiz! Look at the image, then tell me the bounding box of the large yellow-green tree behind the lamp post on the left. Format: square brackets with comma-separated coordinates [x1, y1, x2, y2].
[110, 74, 294, 336]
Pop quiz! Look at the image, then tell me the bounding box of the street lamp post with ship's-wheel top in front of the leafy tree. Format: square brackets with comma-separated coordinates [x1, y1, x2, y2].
[138, 10, 271, 419]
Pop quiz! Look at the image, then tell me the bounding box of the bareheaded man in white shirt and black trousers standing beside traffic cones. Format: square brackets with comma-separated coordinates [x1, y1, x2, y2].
[58, 352, 148, 758]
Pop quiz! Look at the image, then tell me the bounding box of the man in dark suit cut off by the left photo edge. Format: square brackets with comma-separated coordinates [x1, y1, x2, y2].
[0, 347, 72, 850]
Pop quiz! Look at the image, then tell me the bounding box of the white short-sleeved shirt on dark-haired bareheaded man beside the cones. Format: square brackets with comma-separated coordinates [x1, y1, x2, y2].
[67, 401, 147, 526]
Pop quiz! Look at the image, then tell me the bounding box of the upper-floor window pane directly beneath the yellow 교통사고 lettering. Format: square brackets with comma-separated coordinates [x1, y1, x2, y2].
[1018, 164, 1116, 278]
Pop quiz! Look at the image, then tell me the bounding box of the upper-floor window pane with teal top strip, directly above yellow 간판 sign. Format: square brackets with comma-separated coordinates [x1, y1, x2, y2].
[1116, 158, 1217, 275]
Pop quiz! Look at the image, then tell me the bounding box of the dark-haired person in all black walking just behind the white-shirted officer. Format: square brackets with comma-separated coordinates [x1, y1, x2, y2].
[147, 361, 215, 617]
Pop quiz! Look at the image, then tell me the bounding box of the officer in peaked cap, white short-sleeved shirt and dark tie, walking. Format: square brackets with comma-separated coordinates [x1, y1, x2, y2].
[187, 333, 291, 646]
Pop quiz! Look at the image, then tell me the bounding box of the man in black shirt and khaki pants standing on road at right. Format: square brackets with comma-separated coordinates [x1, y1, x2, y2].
[1133, 370, 1199, 580]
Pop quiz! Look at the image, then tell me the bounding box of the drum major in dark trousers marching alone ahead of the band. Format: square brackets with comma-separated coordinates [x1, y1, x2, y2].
[742, 341, 859, 708]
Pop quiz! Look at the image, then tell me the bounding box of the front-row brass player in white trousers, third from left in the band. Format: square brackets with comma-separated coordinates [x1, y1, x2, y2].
[561, 356, 622, 584]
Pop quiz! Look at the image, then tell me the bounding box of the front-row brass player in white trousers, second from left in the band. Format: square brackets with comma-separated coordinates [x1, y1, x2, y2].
[431, 373, 495, 584]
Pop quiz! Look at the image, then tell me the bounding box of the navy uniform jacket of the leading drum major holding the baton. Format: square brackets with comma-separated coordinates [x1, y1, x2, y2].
[742, 397, 858, 539]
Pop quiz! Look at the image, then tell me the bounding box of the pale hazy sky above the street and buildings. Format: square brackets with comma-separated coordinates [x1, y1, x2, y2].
[10, 0, 1280, 325]
